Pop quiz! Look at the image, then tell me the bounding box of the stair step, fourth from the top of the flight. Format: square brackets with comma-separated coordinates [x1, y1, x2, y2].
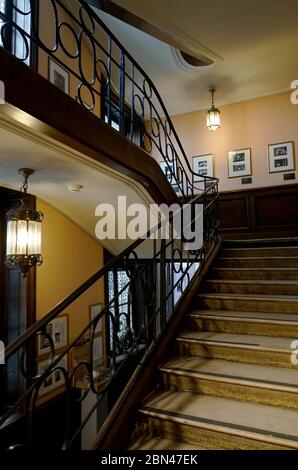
[208, 268, 298, 280]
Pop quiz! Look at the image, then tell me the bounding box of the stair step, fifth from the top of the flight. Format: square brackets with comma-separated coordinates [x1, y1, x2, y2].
[205, 279, 298, 298]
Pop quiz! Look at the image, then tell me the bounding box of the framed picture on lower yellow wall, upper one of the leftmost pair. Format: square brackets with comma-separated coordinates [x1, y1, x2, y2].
[38, 315, 68, 356]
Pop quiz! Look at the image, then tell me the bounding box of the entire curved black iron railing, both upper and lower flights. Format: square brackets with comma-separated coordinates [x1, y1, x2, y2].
[0, 0, 218, 449]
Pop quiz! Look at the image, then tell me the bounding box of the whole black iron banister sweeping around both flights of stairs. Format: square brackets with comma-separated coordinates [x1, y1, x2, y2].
[0, 0, 218, 449]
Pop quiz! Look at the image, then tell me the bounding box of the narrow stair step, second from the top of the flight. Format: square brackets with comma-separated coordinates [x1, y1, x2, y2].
[221, 246, 298, 258]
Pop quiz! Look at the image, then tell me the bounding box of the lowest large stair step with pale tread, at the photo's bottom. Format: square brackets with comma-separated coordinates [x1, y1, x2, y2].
[140, 391, 298, 450]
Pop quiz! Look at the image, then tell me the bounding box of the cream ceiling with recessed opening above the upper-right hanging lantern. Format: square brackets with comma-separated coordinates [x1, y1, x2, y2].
[97, 0, 298, 115]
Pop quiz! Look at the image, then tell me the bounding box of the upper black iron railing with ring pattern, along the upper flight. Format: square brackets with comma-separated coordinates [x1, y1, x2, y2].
[0, 0, 218, 199]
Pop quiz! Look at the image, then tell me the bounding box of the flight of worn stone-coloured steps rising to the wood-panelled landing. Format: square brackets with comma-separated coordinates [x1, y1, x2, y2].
[129, 239, 298, 450]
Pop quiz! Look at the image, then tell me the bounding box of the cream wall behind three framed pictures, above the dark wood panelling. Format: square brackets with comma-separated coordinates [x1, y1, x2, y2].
[172, 93, 298, 191]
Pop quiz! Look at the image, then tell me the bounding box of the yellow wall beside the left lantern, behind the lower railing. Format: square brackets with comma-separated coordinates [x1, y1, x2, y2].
[36, 200, 104, 339]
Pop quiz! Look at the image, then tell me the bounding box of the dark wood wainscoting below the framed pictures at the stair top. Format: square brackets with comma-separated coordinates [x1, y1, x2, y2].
[219, 184, 298, 239]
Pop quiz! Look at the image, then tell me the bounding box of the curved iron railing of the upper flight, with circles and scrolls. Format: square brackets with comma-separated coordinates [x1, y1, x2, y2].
[0, 0, 213, 199]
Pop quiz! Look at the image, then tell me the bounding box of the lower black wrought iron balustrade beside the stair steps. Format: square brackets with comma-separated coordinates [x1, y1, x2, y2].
[0, 182, 218, 449]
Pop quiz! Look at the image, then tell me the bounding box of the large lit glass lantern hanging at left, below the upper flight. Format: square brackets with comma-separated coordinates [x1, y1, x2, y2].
[5, 168, 43, 277]
